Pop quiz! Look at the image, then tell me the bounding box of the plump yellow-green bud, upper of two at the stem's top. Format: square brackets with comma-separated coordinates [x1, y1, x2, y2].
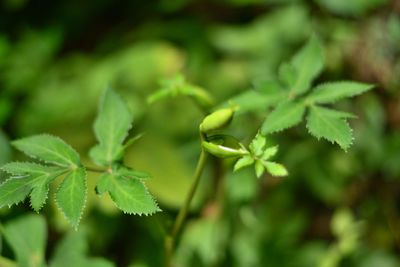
[200, 108, 234, 133]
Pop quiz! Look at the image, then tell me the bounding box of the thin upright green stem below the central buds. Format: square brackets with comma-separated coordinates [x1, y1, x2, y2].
[164, 149, 208, 267]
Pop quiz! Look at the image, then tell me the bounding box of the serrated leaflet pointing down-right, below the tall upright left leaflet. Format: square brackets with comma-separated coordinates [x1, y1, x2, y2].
[96, 169, 160, 215]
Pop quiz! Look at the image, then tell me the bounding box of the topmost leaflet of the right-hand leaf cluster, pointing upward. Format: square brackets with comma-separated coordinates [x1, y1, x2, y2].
[290, 36, 324, 95]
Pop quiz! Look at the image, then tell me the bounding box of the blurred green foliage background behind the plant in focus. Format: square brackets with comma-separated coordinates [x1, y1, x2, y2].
[0, 0, 400, 267]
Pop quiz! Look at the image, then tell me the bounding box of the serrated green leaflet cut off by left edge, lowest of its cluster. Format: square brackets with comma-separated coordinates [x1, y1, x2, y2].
[0, 178, 31, 207]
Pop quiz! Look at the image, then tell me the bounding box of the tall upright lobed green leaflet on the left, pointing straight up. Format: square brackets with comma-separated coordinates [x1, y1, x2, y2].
[90, 89, 133, 166]
